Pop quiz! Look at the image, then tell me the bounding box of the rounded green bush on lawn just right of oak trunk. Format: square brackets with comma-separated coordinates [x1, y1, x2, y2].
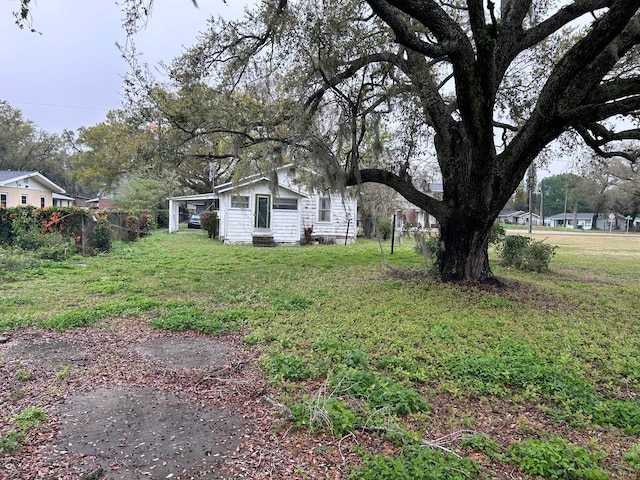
[498, 235, 556, 273]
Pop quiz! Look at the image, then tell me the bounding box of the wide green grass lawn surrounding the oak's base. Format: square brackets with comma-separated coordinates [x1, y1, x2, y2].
[0, 232, 640, 479]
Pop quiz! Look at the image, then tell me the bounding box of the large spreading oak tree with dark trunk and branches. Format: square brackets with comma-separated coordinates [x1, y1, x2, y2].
[168, 0, 640, 281]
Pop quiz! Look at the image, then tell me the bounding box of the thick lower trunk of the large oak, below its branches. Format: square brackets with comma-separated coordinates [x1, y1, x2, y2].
[438, 209, 500, 283]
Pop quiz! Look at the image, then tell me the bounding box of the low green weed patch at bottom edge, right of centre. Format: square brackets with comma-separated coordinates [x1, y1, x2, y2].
[347, 447, 480, 480]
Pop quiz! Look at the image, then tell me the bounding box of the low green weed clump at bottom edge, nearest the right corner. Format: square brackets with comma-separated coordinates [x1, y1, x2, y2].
[508, 438, 609, 480]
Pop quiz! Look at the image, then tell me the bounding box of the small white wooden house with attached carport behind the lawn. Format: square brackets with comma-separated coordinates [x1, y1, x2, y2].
[169, 165, 357, 245]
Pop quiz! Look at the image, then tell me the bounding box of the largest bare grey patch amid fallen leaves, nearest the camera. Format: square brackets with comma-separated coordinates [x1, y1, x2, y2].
[57, 387, 244, 479]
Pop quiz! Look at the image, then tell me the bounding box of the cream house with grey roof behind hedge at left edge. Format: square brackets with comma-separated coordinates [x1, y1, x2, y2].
[0, 170, 73, 208]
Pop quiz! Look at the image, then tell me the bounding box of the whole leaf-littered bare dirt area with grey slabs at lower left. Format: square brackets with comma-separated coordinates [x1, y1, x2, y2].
[0, 319, 271, 480]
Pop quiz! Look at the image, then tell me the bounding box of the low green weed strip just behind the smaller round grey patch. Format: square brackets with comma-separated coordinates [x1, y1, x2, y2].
[151, 306, 251, 335]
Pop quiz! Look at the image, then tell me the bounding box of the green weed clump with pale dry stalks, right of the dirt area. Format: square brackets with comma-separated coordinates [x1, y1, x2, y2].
[291, 384, 356, 437]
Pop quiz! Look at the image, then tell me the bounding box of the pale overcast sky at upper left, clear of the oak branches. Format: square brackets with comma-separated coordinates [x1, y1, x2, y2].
[0, 0, 251, 133]
